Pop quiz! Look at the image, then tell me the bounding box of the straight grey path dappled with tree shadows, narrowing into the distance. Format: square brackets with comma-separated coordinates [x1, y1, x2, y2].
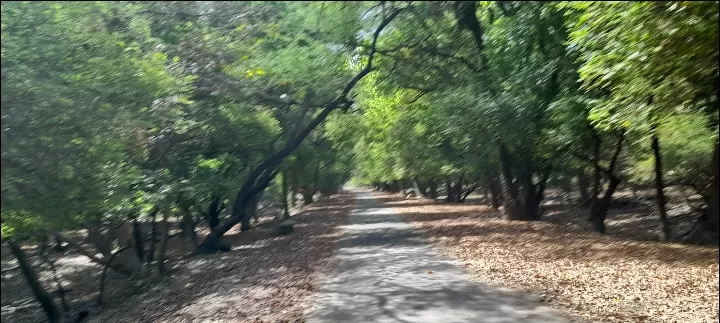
[307, 189, 567, 323]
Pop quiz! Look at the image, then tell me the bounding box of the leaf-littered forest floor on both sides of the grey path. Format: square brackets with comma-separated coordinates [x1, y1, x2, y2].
[0, 193, 720, 323]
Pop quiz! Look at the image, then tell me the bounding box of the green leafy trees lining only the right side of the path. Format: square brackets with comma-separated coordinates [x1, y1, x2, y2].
[356, 2, 720, 241]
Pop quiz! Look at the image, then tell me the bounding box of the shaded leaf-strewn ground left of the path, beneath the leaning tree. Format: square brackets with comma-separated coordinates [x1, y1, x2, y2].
[2, 194, 352, 323]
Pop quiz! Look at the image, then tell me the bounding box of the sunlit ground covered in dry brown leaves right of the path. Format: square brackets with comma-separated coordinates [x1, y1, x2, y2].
[377, 194, 718, 322]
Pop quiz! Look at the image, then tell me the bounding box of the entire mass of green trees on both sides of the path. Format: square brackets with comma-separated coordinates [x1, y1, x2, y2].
[1, 1, 720, 322]
